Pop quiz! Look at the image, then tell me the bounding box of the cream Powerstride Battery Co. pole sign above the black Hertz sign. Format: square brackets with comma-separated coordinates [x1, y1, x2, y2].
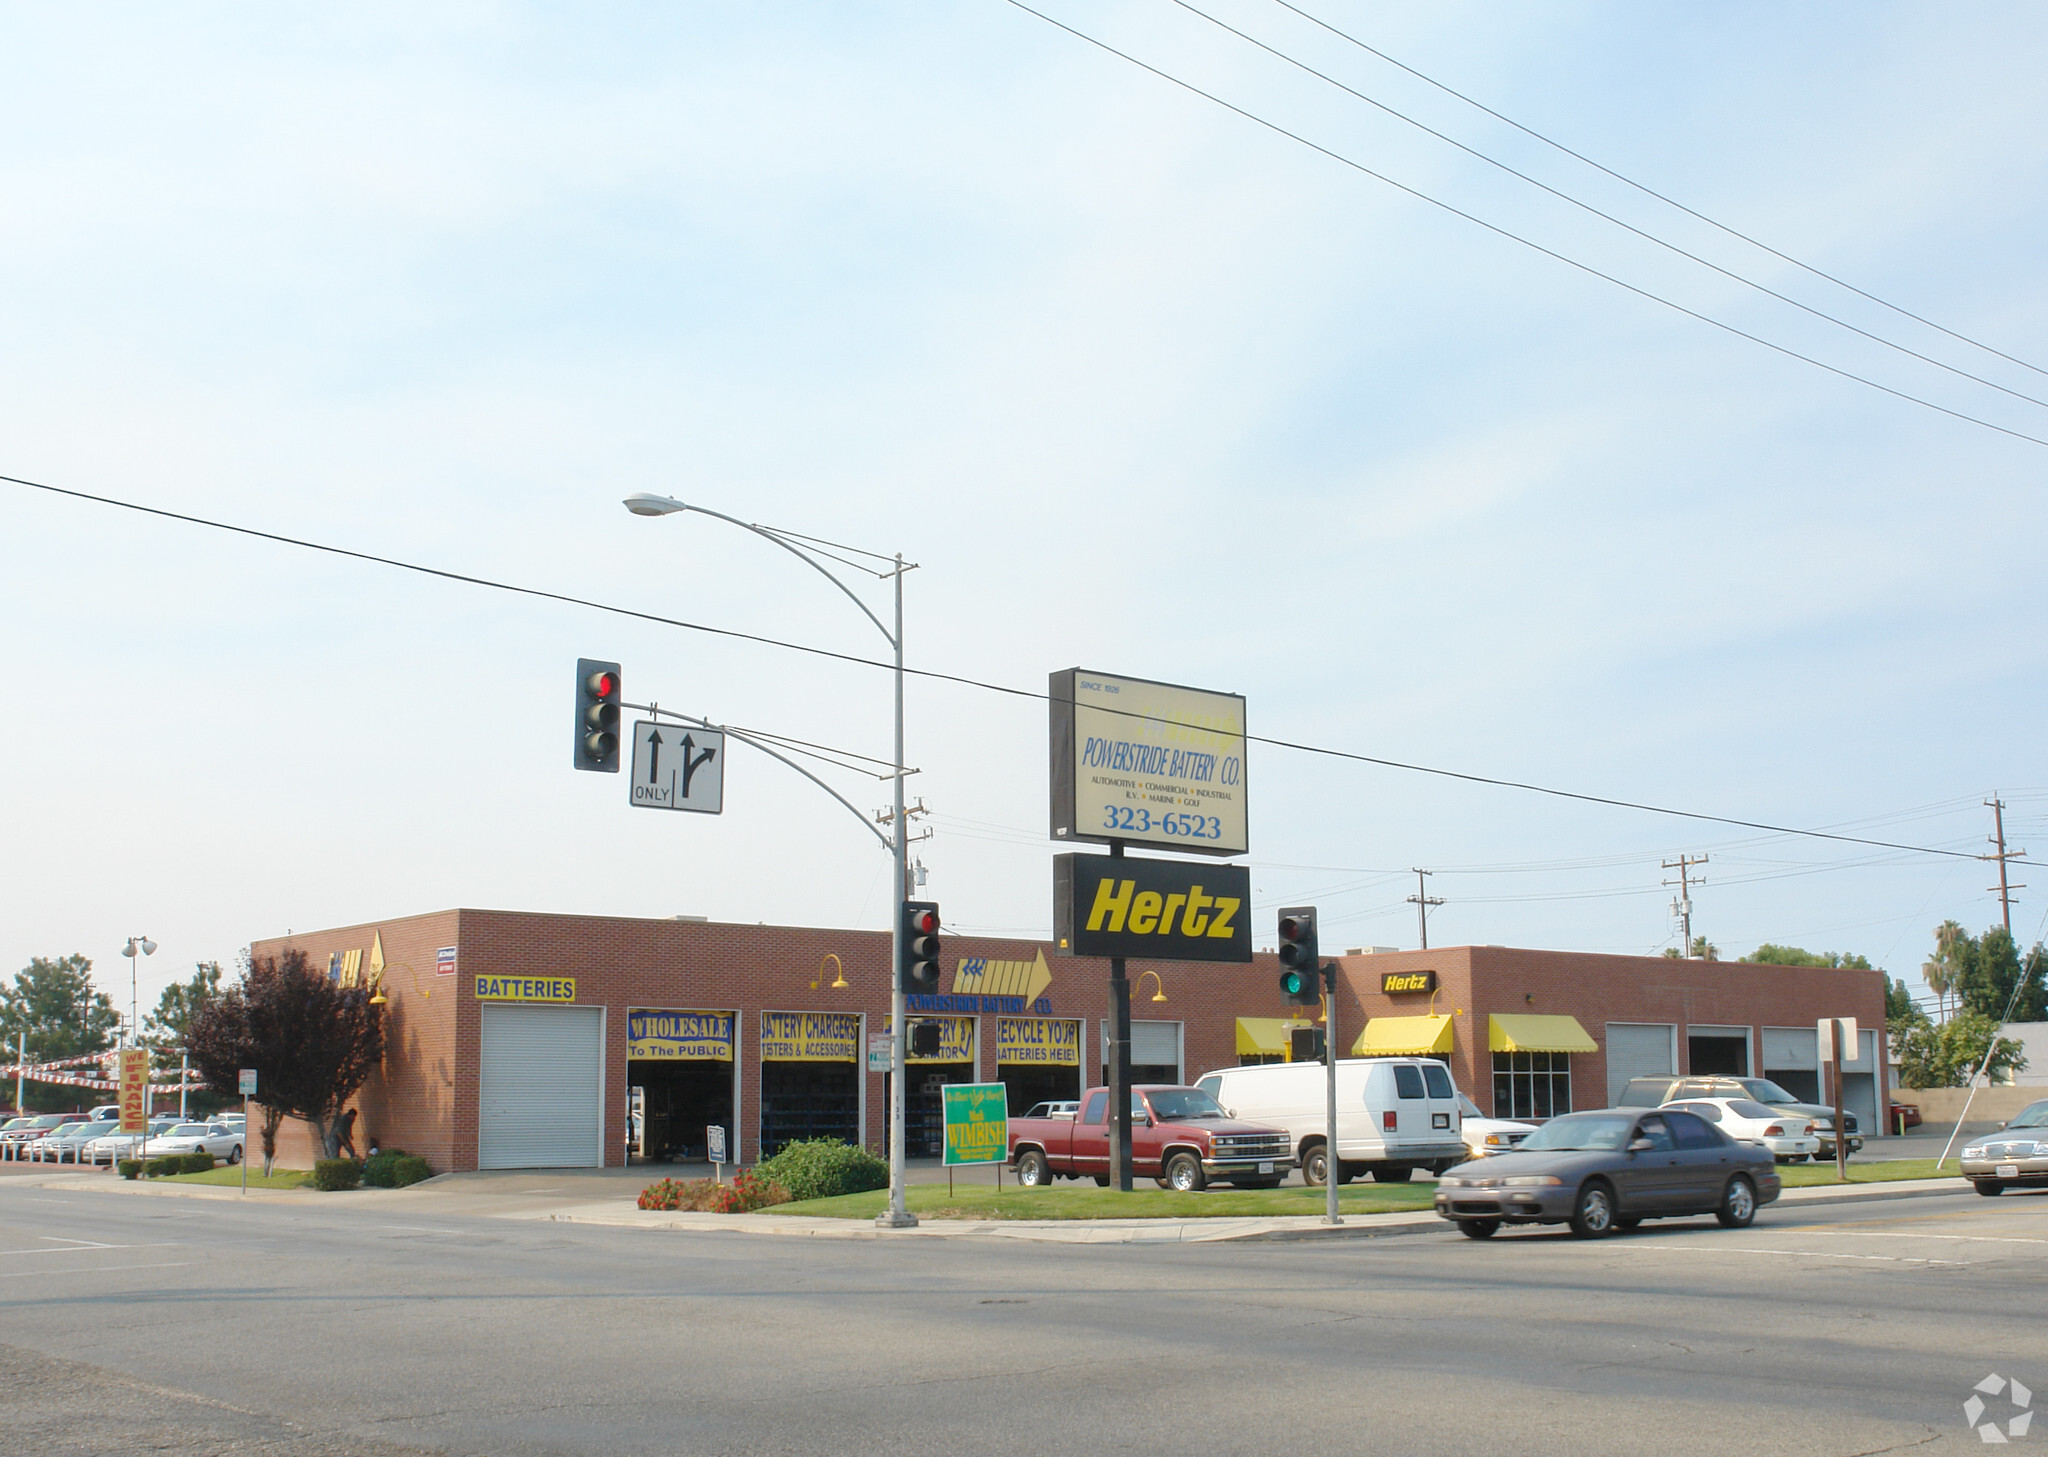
[1049, 668, 1249, 855]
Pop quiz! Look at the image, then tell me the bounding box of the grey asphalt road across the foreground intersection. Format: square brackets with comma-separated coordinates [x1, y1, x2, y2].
[0, 1184, 2048, 1457]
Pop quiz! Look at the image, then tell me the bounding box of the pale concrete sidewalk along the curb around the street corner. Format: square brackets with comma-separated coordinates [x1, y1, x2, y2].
[8, 1168, 1968, 1244]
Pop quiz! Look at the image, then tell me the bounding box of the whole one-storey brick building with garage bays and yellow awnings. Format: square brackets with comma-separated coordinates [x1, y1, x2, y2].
[250, 910, 1884, 1170]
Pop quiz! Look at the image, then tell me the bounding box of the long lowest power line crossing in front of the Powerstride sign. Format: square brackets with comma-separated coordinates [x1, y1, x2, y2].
[0, 475, 2032, 865]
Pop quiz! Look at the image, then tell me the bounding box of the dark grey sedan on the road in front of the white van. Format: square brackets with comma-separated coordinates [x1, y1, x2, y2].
[1436, 1109, 1782, 1240]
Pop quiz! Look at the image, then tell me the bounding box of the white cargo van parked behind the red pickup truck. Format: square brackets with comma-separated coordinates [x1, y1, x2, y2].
[1194, 1057, 1473, 1184]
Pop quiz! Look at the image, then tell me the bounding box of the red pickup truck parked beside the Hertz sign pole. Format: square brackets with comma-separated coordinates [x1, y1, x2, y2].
[1010, 1086, 1294, 1189]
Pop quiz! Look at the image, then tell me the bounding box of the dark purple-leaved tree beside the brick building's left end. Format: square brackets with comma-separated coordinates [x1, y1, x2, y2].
[186, 947, 383, 1172]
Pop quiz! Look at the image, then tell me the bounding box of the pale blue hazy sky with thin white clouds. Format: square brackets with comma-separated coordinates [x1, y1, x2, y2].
[0, 0, 2048, 1032]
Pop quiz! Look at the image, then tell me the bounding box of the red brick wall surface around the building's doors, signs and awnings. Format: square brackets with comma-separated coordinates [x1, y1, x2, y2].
[252, 910, 1884, 1172]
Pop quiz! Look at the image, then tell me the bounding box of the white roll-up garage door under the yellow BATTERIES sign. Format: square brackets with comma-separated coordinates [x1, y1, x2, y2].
[477, 1006, 604, 1168]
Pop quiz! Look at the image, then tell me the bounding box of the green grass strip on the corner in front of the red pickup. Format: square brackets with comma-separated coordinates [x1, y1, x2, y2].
[764, 1178, 1436, 1219]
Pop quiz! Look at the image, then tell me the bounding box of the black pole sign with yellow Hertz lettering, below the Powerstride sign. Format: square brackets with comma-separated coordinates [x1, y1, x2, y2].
[1053, 855, 1251, 961]
